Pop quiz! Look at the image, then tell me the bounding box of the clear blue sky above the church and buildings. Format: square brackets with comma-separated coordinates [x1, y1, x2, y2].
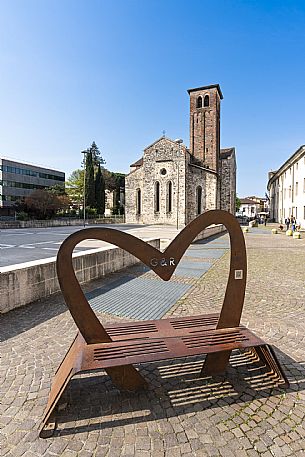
[0, 0, 305, 197]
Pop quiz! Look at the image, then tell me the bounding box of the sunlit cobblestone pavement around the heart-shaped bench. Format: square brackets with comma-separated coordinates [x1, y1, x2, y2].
[0, 229, 305, 457]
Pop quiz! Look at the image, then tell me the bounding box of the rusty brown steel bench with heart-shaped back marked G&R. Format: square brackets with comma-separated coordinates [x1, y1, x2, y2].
[40, 210, 288, 437]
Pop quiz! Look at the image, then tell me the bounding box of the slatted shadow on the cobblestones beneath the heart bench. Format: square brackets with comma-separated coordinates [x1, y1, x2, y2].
[53, 348, 305, 437]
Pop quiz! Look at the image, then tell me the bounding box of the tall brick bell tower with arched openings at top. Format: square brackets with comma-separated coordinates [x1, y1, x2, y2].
[188, 84, 223, 172]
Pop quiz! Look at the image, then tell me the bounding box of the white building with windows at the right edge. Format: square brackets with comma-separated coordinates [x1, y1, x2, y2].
[267, 145, 305, 228]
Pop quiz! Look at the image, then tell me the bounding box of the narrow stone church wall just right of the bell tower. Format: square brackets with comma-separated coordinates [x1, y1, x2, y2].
[220, 154, 236, 215]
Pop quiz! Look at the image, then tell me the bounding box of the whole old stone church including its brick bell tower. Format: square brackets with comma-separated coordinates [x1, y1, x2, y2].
[125, 84, 236, 227]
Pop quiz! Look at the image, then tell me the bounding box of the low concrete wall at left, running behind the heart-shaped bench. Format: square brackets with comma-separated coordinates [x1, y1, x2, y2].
[0, 239, 160, 313]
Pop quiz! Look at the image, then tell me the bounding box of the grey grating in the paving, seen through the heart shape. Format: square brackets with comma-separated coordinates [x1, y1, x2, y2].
[86, 235, 229, 320]
